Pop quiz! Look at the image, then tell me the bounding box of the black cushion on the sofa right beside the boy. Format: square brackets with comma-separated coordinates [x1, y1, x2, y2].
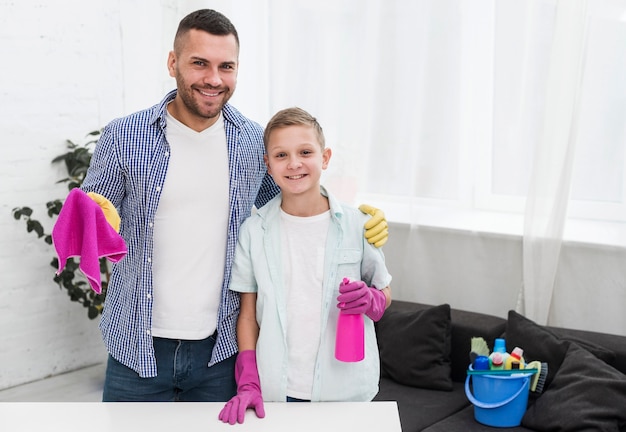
[376, 303, 452, 391]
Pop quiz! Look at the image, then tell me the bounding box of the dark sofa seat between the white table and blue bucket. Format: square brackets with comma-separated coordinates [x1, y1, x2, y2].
[374, 378, 470, 432]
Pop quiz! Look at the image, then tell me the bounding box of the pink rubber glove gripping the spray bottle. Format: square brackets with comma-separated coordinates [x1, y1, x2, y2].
[337, 278, 387, 321]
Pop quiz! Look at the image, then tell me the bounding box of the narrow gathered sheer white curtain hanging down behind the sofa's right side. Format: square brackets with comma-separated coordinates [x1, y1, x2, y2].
[518, 0, 587, 324]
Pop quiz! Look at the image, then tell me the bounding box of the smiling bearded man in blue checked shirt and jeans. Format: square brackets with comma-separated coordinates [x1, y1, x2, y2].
[82, 9, 387, 401]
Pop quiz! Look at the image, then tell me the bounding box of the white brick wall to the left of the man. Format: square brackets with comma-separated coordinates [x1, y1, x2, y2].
[0, 0, 193, 389]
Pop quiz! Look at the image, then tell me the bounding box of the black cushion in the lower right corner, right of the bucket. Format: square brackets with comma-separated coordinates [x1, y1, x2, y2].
[522, 343, 626, 431]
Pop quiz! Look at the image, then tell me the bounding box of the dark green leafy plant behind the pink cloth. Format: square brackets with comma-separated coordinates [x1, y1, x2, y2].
[12, 130, 109, 319]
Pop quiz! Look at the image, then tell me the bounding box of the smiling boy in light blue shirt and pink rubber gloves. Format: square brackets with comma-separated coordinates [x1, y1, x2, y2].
[219, 108, 391, 424]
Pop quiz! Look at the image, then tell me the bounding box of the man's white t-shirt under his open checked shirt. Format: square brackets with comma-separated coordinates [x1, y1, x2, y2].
[152, 109, 230, 340]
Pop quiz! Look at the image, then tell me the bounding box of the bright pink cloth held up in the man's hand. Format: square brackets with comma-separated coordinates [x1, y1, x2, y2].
[52, 188, 128, 294]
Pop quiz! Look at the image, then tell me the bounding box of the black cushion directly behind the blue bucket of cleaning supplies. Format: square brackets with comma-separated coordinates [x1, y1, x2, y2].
[505, 310, 615, 387]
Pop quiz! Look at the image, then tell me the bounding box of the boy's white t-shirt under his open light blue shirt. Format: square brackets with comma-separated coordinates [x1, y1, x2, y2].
[280, 210, 330, 400]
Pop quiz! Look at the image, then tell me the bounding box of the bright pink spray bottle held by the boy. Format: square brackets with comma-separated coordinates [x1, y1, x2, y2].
[335, 278, 365, 362]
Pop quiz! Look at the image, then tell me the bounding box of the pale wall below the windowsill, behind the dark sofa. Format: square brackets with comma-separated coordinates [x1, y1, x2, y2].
[384, 223, 626, 336]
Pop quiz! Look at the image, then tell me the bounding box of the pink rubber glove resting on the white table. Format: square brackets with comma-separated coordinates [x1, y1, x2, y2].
[219, 350, 265, 425]
